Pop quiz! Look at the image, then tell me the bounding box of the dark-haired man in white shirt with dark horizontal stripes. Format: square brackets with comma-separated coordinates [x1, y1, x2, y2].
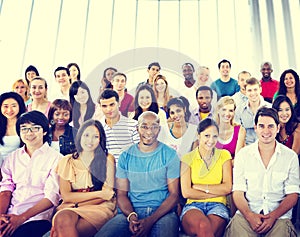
[99, 89, 140, 163]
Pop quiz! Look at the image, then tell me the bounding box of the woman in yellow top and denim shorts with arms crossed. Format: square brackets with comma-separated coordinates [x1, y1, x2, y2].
[180, 118, 232, 237]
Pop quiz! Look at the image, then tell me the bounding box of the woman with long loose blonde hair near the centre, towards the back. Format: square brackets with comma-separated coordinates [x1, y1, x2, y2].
[153, 74, 172, 115]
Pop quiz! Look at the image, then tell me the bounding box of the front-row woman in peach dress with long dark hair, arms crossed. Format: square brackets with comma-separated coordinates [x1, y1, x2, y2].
[51, 120, 116, 237]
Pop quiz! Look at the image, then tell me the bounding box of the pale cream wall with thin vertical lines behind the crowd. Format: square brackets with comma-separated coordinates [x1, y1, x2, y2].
[0, 0, 300, 95]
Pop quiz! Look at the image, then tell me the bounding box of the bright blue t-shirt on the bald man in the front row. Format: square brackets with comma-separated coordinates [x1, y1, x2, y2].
[116, 142, 180, 208]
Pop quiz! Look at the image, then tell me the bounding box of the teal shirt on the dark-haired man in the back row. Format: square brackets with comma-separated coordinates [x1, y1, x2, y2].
[210, 77, 240, 99]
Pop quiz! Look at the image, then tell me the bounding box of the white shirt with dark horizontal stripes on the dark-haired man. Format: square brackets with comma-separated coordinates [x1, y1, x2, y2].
[101, 114, 140, 164]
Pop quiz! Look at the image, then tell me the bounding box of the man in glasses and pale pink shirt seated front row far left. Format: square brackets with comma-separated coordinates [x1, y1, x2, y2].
[0, 111, 61, 237]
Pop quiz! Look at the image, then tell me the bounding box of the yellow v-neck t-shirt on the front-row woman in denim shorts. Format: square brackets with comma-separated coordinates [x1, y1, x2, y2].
[182, 147, 231, 205]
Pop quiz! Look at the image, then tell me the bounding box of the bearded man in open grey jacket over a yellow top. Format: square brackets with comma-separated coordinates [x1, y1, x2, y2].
[189, 86, 213, 125]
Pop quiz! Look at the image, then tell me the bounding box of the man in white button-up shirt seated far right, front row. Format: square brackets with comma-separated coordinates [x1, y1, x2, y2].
[225, 108, 299, 237]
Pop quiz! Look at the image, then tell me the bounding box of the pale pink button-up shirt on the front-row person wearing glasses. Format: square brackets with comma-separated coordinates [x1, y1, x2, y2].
[0, 142, 62, 221]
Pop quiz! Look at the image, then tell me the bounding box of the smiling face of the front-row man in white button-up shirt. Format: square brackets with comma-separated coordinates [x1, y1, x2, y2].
[254, 116, 279, 144]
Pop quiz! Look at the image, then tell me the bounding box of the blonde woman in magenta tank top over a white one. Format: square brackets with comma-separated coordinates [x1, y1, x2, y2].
[215, 96, 246, 159]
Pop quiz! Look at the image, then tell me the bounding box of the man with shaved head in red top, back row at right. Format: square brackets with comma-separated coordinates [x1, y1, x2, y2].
[260, 62, 279, 103]
